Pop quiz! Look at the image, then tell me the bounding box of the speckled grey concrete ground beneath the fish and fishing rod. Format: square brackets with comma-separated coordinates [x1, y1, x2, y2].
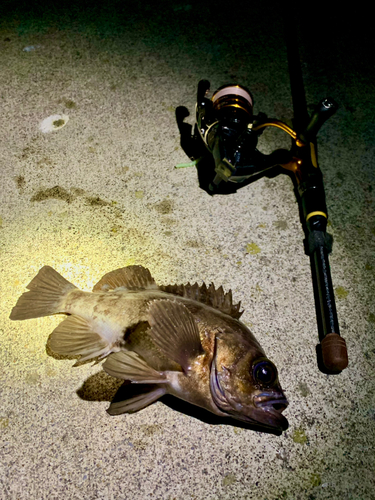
[0, 0, 375, 500]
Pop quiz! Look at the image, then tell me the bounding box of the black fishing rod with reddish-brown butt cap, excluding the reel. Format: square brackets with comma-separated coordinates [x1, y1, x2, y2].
[284, 5, 348, 373]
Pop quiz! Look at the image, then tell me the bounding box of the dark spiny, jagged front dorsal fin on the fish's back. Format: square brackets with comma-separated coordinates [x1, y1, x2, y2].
[159, 283, 243, 319]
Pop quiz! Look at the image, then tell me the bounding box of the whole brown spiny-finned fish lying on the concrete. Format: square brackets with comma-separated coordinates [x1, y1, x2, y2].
[10, 265, 288, 432]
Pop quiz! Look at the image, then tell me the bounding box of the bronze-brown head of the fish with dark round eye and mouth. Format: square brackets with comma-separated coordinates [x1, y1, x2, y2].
[210, 335, 288, 431]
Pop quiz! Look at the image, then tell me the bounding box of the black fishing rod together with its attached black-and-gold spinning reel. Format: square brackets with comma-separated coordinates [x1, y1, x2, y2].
[176, 26, 348, 373]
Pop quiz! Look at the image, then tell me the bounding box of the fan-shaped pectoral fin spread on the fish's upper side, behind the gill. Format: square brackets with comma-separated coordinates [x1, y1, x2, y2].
[148, 300, 204, 373]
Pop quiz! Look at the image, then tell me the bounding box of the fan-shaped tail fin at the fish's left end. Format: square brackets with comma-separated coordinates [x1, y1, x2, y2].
[9, 266, 76, 320]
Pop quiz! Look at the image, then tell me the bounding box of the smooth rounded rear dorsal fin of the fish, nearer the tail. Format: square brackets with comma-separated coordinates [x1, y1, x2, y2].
[93, 266, 159, 292]
